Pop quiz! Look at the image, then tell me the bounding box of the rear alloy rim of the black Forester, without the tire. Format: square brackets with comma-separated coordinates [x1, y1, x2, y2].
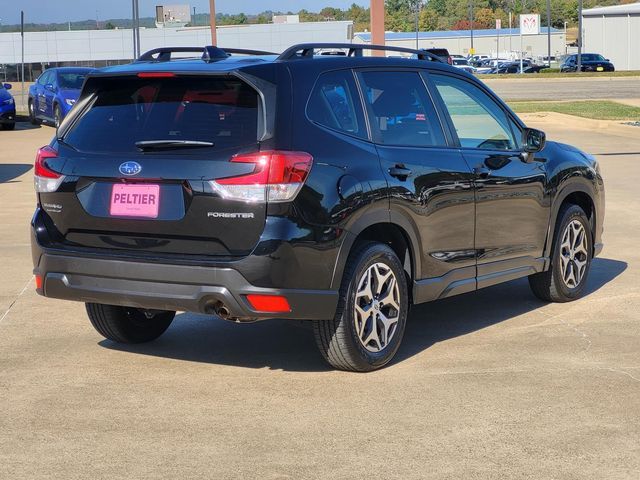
[354, 263, 400, 352]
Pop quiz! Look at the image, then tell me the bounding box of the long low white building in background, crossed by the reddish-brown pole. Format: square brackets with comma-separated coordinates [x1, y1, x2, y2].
[354, 27, 566, 58]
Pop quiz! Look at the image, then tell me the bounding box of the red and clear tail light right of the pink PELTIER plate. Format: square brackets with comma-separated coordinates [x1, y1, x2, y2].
[209, 151, 313, 202]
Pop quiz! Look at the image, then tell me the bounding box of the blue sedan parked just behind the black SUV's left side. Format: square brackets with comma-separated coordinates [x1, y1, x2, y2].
[29, 67, 95, 127]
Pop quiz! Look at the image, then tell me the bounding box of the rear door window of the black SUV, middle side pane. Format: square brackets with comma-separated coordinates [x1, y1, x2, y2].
[360, 71, 446, 147]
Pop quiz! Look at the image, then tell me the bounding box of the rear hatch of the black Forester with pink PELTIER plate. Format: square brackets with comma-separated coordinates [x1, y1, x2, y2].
[40, 73, 266, 256]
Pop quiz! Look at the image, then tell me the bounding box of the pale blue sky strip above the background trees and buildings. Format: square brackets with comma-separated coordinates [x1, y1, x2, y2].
[0, 0, 369, 25]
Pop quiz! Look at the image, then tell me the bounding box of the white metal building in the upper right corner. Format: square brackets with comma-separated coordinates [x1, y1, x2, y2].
[582, 3, 640, 70]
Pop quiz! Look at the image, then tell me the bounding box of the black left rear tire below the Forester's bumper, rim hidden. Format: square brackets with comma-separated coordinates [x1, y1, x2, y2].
[86, 303, 176, 343]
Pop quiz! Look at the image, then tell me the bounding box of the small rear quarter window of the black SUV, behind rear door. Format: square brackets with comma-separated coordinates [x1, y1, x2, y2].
[307, 70, 367, 138]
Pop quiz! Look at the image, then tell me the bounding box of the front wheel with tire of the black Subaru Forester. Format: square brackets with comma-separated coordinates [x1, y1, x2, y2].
[529, 204, 593, 302]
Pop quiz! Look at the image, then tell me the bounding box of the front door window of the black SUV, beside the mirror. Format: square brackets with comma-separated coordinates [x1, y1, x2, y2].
[431, 75, 516, 150]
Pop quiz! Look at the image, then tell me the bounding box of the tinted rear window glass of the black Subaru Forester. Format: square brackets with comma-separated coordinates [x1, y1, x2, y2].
[64, 77, 258, 153]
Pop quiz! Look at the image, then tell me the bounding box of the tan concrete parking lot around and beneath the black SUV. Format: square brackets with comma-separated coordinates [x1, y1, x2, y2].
[0, 114, 640, 479]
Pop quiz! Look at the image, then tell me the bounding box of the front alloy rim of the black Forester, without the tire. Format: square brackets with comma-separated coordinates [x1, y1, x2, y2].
[560, 220, 589, 288]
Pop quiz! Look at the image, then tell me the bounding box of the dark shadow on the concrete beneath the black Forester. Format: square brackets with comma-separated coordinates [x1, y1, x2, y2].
[99, 258, 627, 372]
